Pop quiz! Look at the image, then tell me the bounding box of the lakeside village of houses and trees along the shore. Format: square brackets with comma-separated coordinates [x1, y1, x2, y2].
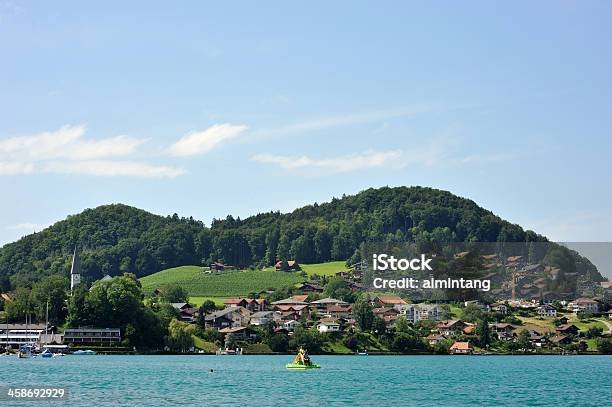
[0, 253, 612, 354]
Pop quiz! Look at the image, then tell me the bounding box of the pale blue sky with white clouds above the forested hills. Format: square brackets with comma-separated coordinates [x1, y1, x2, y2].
[0, 0, 612, 276]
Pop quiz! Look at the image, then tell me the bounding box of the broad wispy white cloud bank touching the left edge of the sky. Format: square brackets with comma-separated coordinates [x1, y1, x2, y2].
[0, 125, 186, 178]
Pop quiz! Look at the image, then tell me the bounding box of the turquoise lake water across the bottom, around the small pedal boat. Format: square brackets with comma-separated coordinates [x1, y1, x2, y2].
[0, 355, 612, 406]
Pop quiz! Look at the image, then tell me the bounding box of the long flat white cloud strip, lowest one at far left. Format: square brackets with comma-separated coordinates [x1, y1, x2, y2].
[41, 160, 187, 178]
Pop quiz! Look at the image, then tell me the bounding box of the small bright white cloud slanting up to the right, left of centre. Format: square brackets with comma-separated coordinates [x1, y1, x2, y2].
[168, 123, 247, 156]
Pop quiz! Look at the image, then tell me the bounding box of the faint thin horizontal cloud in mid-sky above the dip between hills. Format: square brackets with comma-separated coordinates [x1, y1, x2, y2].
[252, 150, 410, 172]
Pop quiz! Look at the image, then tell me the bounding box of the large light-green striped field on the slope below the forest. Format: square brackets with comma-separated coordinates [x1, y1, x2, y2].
[140, 266, 304, 301]
